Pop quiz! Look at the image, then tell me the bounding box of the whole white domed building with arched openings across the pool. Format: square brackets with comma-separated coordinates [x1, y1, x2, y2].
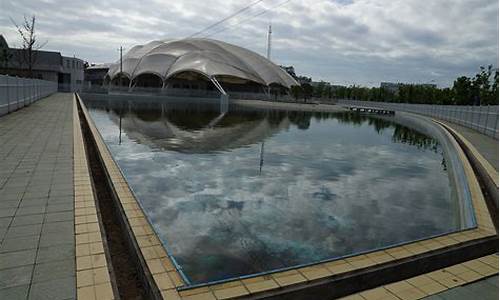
[105, 38, 299, 93]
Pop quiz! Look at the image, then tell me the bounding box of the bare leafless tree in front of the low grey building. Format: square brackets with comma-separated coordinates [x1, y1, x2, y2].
[11, 15, 47, 78]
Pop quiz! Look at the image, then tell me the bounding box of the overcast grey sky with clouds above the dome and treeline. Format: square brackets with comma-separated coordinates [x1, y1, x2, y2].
[0, 0, 498, 86]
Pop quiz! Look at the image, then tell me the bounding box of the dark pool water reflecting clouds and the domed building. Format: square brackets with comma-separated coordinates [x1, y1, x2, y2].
[86, 101, 460, 283]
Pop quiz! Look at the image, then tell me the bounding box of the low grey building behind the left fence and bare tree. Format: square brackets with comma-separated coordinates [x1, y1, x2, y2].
[0, 35, 84, 92]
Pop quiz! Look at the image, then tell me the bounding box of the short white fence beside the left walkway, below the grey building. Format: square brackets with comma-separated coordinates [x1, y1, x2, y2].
[0, 75, 57, 116]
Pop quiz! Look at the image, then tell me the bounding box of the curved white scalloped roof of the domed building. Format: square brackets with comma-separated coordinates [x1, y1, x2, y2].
[108, 38, 299, 87]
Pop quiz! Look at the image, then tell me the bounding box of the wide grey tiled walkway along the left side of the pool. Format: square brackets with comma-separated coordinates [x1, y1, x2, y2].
[0, 94, 76, 299]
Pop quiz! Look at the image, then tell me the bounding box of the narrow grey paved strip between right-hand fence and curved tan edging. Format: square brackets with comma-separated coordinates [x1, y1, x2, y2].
[445, 122, 498, 171]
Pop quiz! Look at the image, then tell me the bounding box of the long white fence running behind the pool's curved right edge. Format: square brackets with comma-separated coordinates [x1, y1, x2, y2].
[338, 100, 498, 140]
